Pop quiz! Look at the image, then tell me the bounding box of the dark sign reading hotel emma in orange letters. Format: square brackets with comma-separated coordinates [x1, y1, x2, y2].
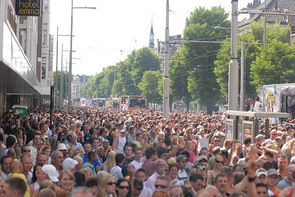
[15, 0, 40, 16]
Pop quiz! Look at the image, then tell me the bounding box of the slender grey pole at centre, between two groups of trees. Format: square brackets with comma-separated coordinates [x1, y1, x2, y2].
[163, 0, 169, 120]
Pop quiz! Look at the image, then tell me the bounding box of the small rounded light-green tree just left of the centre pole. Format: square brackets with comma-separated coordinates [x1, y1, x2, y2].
[138, 70, 163, 104]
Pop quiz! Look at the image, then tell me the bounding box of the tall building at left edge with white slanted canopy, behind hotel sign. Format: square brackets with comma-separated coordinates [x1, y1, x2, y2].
[0, 0, 53, 113]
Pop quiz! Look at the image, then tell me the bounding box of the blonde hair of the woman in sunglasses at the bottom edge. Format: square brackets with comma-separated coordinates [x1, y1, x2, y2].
[96, 173, 117, 197]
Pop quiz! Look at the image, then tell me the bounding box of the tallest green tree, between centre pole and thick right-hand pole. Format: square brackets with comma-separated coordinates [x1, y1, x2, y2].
[184, 6, 230, 113]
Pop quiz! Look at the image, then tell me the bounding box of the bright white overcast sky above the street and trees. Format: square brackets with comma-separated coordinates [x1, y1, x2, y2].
[50, 0, 253, 75]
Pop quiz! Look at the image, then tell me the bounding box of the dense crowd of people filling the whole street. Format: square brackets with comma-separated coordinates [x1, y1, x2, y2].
[0, 107, 295, 197]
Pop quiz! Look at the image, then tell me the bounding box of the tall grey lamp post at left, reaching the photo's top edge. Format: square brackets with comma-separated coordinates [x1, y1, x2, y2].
[68, 0, 73, 110]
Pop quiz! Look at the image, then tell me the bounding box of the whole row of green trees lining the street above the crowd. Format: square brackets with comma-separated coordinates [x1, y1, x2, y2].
[78, 7, 295, 111]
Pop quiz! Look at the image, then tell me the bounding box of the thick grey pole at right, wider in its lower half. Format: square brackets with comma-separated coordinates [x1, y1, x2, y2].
[228, 0, 239, 110]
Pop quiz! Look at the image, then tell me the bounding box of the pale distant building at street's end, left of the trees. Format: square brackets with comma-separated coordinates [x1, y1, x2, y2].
[72, 75, 91, 99]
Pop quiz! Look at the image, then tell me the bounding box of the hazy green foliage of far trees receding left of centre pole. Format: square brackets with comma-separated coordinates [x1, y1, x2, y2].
[81, 47, 160, 98]
